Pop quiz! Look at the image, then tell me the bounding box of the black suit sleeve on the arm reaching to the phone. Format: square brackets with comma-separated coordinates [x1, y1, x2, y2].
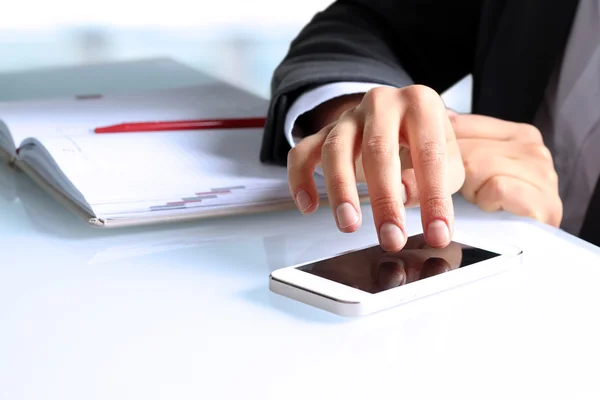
[260, 0, 481, 165]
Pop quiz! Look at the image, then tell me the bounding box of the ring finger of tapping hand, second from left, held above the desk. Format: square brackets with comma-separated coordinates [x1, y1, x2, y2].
[321, 113, 361, 232]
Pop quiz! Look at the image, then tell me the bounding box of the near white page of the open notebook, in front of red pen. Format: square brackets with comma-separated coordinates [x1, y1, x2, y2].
[29, 129, 310, 213]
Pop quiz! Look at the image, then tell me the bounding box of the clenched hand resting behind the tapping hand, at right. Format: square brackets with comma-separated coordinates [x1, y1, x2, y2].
[450, 112, 562, 227]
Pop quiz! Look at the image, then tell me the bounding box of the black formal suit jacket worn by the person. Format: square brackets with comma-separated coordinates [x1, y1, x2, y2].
[260, 0, 600, 244]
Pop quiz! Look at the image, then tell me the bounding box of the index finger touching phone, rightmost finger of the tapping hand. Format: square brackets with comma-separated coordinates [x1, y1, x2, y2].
[401, 89, 454, 248]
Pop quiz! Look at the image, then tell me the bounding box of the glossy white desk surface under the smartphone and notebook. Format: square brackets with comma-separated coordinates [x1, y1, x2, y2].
[0, 59, 600, 400]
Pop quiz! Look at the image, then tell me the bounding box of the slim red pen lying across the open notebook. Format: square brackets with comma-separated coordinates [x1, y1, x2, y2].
[94, 117, 266, 133]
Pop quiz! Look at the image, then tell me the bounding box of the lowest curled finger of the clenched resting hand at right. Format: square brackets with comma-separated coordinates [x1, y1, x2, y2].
[474, 176, 562, 227]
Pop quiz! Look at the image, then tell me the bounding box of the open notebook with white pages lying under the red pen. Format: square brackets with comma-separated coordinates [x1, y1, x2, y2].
[0, 74, 366, 227]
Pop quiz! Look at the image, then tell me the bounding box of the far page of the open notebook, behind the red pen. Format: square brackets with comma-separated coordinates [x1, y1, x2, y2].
[0, 80, 268, 145]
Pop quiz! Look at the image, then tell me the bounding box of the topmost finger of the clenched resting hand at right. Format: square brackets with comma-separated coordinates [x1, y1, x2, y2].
[450, 114, 542, 143]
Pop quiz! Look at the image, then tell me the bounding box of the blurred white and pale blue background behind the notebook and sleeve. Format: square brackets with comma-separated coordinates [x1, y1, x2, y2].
[0, 0, 469, 108]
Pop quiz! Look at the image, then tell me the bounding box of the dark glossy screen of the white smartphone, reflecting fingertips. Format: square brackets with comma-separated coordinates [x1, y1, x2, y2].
[298, 235, 500, 293]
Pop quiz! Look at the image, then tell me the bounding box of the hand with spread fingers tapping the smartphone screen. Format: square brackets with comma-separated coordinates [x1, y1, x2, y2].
[288, 85, 464, 251]
